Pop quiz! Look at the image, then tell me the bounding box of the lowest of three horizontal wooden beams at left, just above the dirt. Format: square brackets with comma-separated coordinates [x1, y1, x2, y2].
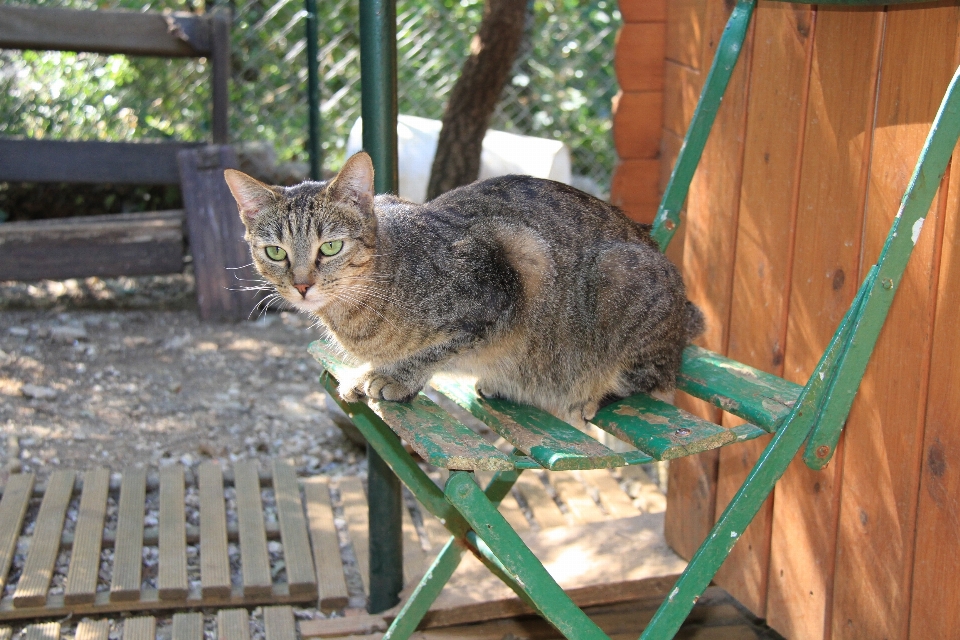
[0, 211, 184, 280]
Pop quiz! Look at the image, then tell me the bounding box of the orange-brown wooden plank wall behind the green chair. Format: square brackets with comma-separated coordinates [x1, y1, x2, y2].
[612, 0, 960, 639]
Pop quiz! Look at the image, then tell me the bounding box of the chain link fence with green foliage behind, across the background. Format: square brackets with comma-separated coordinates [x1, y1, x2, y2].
[0, 0, 620, 195]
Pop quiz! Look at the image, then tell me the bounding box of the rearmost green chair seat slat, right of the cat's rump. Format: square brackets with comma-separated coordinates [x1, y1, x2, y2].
[677, 345, 803, 433]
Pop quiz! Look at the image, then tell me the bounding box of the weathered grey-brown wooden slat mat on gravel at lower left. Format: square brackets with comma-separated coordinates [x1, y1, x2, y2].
[0, 461, 320, 620]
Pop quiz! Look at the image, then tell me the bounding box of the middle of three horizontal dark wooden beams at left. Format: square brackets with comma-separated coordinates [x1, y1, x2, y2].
[0, 138, 198, 185]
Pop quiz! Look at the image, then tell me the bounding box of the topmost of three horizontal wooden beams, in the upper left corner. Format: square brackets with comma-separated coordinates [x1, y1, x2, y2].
[0, 6, 212, 58]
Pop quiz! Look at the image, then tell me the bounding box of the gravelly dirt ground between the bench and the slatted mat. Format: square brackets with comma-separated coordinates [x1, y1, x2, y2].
[0, 276, 363, 476]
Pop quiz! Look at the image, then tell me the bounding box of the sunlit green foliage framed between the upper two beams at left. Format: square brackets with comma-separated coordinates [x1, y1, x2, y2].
[0, 0, 210, 141]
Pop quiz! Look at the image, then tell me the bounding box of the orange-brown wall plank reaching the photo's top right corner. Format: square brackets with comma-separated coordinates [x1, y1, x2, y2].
[832, 6, 960, 639]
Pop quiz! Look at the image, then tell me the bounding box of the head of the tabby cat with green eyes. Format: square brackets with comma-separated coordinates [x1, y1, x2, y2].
[224, 151, 377, 312]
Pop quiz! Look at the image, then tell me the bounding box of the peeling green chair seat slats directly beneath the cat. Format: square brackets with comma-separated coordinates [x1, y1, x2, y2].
[309, 340, 766, 471]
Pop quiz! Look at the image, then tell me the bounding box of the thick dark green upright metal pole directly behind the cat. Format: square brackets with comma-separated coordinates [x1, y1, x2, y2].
[360, 0, 403, 613]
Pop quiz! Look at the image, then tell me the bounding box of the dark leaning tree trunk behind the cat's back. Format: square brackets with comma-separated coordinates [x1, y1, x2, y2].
[427, 0, 527, 200]
